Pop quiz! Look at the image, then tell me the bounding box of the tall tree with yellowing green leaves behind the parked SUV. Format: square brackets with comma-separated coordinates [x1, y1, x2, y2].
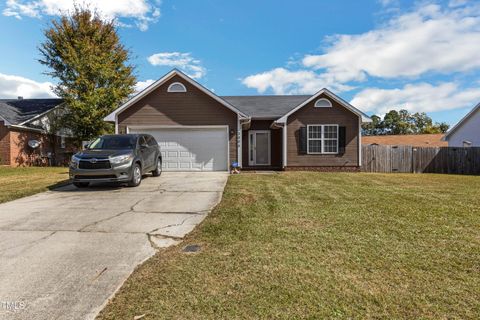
[39, 6, 136, 143]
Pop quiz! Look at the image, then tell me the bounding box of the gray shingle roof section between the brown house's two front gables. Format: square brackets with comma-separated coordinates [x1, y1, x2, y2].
[220, 96, 311, 118]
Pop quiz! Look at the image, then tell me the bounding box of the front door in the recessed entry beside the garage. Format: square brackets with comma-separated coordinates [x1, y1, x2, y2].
[248, 130, 270, 166]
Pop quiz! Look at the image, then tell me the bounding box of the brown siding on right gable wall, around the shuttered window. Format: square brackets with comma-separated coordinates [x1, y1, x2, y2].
[287, 95, 359, 167]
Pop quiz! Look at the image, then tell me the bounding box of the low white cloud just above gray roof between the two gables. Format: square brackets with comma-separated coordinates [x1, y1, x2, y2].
[242, 68, 352, 94]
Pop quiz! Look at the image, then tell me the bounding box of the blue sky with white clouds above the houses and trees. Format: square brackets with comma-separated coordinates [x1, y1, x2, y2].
[0, 0, 480, 124]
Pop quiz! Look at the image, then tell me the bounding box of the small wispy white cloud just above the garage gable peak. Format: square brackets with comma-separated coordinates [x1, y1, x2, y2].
[147, 52, 207, 79]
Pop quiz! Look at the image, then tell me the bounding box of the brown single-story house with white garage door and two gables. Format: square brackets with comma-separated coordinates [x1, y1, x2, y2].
[105, 70, 371, 171]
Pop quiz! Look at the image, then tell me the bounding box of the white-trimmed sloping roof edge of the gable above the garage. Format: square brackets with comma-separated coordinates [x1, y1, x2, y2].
[104, 69, 247, 121]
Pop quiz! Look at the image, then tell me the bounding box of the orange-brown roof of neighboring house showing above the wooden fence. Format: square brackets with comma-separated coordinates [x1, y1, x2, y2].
[362, 133, 448, 147]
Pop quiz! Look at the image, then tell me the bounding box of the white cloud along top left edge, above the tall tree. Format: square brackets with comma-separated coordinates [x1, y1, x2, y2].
[3, 0, 160, 30]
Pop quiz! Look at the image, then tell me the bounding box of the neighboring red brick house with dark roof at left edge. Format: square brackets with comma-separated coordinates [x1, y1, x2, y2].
[0, 97, 72, 166]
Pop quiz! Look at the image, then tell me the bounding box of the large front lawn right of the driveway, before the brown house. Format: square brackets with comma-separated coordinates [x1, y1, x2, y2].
[99, 172, 480, 319]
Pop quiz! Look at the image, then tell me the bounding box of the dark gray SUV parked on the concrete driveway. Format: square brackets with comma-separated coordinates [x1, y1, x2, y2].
[70, 134, 162, 188]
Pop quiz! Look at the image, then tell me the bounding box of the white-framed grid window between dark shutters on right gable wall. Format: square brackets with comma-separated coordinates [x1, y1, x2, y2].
[307, 124, 338, 154]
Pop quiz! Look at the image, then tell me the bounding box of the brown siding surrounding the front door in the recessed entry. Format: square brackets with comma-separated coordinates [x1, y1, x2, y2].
[242, 120, 283, 168]
